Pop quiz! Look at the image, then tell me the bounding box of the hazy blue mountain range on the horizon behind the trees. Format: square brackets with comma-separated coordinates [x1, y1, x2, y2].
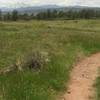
[0, 5, 100, 13]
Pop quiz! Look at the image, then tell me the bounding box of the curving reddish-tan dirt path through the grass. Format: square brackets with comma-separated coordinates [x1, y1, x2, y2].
[62, 53, 100, 100]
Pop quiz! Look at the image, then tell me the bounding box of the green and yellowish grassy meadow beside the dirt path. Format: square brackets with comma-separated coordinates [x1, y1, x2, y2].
[0, 20, 100, 100]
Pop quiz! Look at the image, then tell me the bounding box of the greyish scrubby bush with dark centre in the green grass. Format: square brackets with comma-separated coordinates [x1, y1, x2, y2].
[15, 52, 49, 71]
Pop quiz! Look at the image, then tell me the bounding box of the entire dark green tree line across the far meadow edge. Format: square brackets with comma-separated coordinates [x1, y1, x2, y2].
[0, 9, 100, 21]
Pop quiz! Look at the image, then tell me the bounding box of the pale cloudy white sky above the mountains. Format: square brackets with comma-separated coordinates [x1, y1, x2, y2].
[0, 0, 100, 7]
